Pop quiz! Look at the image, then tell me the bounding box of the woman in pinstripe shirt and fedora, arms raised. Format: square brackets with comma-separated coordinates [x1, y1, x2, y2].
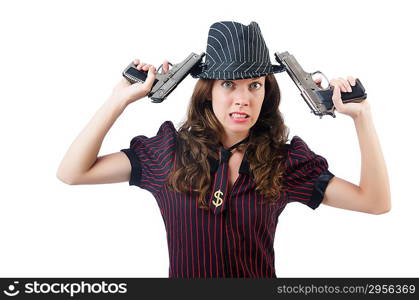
[57, 22, 390, 278]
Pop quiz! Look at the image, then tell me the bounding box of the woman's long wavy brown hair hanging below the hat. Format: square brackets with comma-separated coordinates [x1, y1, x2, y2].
[168, 75, 289, 209]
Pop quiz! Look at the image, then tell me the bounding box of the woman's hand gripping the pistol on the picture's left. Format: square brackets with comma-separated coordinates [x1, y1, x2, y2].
[112, 59, 169, 105]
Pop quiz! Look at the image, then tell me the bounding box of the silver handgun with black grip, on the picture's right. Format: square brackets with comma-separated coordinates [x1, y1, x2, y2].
[275, 51, 367, 118]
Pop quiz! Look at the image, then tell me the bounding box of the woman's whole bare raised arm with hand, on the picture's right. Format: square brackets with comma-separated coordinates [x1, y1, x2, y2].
[322, 77, 391, 214]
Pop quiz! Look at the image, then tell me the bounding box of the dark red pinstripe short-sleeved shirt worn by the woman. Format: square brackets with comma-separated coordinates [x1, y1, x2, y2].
[121, 121, 334, 278]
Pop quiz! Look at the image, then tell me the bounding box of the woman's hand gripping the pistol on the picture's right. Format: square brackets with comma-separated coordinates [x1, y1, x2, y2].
[314, 76, 370, 119]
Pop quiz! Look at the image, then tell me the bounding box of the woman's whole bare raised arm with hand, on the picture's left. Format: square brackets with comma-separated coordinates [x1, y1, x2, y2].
[57, 60, 164, 184]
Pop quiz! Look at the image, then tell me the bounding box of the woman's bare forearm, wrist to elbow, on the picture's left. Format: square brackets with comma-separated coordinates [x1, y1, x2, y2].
[57, 97, 126, 181]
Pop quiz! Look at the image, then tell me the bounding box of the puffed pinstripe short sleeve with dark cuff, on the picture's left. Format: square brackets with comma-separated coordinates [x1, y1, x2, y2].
[121, 121, 177, 194]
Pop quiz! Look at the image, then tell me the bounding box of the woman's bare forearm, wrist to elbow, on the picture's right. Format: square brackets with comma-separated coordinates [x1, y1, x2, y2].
[354, 107, 391, 210]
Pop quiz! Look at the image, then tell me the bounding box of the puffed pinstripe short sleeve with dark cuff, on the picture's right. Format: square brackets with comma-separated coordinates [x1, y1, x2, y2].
[284, 136, 334, 209]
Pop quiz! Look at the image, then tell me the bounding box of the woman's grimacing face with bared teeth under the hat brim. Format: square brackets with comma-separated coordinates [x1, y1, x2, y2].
[211, 76, 265, 134]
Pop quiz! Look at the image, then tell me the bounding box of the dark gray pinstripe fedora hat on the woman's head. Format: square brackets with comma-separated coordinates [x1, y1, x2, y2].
[191, 21, 284, 80]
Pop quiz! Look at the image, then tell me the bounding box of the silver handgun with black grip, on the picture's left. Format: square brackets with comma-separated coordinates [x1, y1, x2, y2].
[122, 52, 205, 103]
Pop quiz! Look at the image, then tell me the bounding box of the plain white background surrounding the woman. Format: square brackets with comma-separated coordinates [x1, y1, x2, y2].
[0, 0, 419, 277]
